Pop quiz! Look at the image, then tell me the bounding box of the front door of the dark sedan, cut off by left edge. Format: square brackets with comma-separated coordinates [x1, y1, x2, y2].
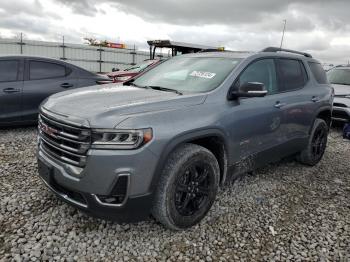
[0, 58, 23, 124]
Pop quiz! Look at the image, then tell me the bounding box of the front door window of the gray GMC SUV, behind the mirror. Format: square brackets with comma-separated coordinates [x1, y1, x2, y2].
[236, 59, 278, 94]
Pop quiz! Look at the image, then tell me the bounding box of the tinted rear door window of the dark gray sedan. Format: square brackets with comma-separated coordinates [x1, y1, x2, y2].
[29, 61, 66, 80]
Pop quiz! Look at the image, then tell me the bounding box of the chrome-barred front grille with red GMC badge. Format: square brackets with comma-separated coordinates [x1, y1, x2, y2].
[39, 114, 91, 167]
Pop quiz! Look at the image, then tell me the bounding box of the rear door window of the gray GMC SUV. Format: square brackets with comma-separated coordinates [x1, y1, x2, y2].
[278, 59, 307, 92]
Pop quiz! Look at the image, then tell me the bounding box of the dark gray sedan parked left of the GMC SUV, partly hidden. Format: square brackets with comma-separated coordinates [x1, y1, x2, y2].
[0, 56, 111, 126]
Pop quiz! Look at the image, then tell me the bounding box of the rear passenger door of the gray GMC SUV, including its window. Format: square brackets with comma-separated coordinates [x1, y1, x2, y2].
[275, 58, 314, 149]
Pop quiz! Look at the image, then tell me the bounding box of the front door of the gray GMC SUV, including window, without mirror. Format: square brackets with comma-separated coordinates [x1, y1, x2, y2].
[229, 59, 282, 169]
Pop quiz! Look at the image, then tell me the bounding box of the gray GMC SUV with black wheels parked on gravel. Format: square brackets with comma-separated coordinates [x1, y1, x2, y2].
[38, 48, 333, 230]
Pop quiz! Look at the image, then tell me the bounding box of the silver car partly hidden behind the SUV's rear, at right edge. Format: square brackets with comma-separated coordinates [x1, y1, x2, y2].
[327, 65, 350, 122]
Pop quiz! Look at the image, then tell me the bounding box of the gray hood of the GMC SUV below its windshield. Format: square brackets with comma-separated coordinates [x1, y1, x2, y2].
[42, 84, 206, 128]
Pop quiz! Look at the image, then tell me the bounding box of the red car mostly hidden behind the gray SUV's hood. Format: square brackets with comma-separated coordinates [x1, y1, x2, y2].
[107, 59, 161, 83]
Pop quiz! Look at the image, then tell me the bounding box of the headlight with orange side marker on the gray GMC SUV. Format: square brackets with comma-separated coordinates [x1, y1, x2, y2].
[91, 128, 153, 149]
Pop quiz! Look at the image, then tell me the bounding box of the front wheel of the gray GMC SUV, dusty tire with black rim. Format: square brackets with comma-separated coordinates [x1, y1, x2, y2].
[152, 144, 220, 230]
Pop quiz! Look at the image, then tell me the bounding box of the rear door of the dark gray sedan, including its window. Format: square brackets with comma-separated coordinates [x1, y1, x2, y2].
[22, 59, 77, 121]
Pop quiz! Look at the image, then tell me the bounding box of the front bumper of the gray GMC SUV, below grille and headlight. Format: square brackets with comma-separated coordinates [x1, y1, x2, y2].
[38, 140, 157, 222]
